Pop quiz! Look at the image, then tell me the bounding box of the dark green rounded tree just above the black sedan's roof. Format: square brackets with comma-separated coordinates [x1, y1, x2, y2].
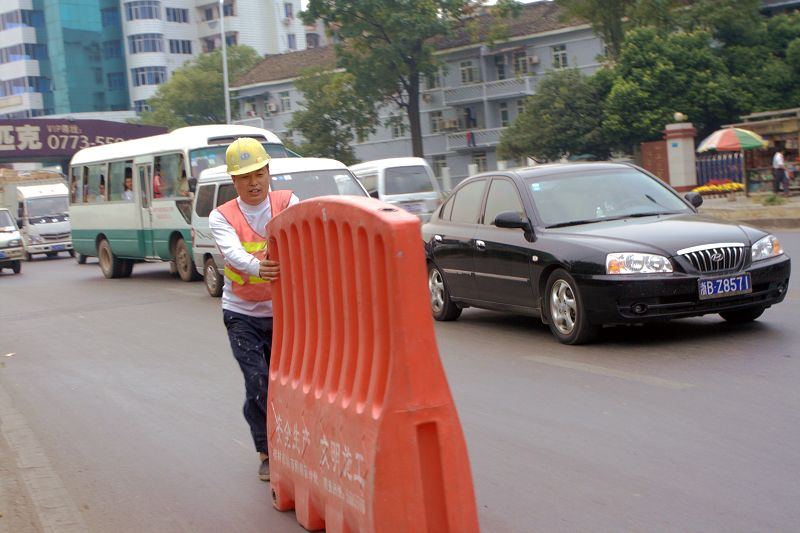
[497, 69, 613, 160]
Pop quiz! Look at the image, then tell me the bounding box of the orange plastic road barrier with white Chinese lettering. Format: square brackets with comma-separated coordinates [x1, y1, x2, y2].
[267, 196, 479, 533]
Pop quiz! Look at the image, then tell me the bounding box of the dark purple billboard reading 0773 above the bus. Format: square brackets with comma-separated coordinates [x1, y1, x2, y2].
[0, 118, 167, 163]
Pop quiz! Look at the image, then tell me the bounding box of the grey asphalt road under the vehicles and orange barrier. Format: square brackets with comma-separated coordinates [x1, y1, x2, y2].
[0, 232, 800, 533]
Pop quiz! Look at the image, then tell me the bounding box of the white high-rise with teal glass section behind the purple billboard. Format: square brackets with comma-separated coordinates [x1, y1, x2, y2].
[0, 0, 306, 118]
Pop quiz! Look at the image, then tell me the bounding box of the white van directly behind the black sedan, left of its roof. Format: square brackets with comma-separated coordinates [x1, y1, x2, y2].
[349, 157, 442, 223]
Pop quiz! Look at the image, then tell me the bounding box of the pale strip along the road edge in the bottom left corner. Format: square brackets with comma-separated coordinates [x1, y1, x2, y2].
[0, 385, 89, 533]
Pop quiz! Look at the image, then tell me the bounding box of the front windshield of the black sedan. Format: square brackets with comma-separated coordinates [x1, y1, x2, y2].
[526, 168, 691, 226]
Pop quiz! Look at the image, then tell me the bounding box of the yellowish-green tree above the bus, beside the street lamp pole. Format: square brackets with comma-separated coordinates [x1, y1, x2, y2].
[139, 46, 261, 130]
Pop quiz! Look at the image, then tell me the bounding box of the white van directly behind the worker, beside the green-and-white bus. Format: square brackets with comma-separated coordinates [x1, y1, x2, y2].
[192, 157, 369, 297]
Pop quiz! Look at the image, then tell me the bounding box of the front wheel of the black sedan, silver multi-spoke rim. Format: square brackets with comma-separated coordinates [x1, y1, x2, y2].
[546, 269, 599, 344]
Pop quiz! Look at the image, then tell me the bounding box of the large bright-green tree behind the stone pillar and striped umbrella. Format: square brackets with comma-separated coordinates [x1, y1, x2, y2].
[603, 28, 739, 150]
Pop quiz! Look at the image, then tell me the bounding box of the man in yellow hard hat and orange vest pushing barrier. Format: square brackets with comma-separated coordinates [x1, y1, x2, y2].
[208, 137, 299, 481]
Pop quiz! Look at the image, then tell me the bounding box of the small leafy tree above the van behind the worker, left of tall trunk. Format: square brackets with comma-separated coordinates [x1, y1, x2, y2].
[287, 69, 377, 165]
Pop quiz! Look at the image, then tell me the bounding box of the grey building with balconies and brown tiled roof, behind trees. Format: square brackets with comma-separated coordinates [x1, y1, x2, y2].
[232, 2, 604, 182]
